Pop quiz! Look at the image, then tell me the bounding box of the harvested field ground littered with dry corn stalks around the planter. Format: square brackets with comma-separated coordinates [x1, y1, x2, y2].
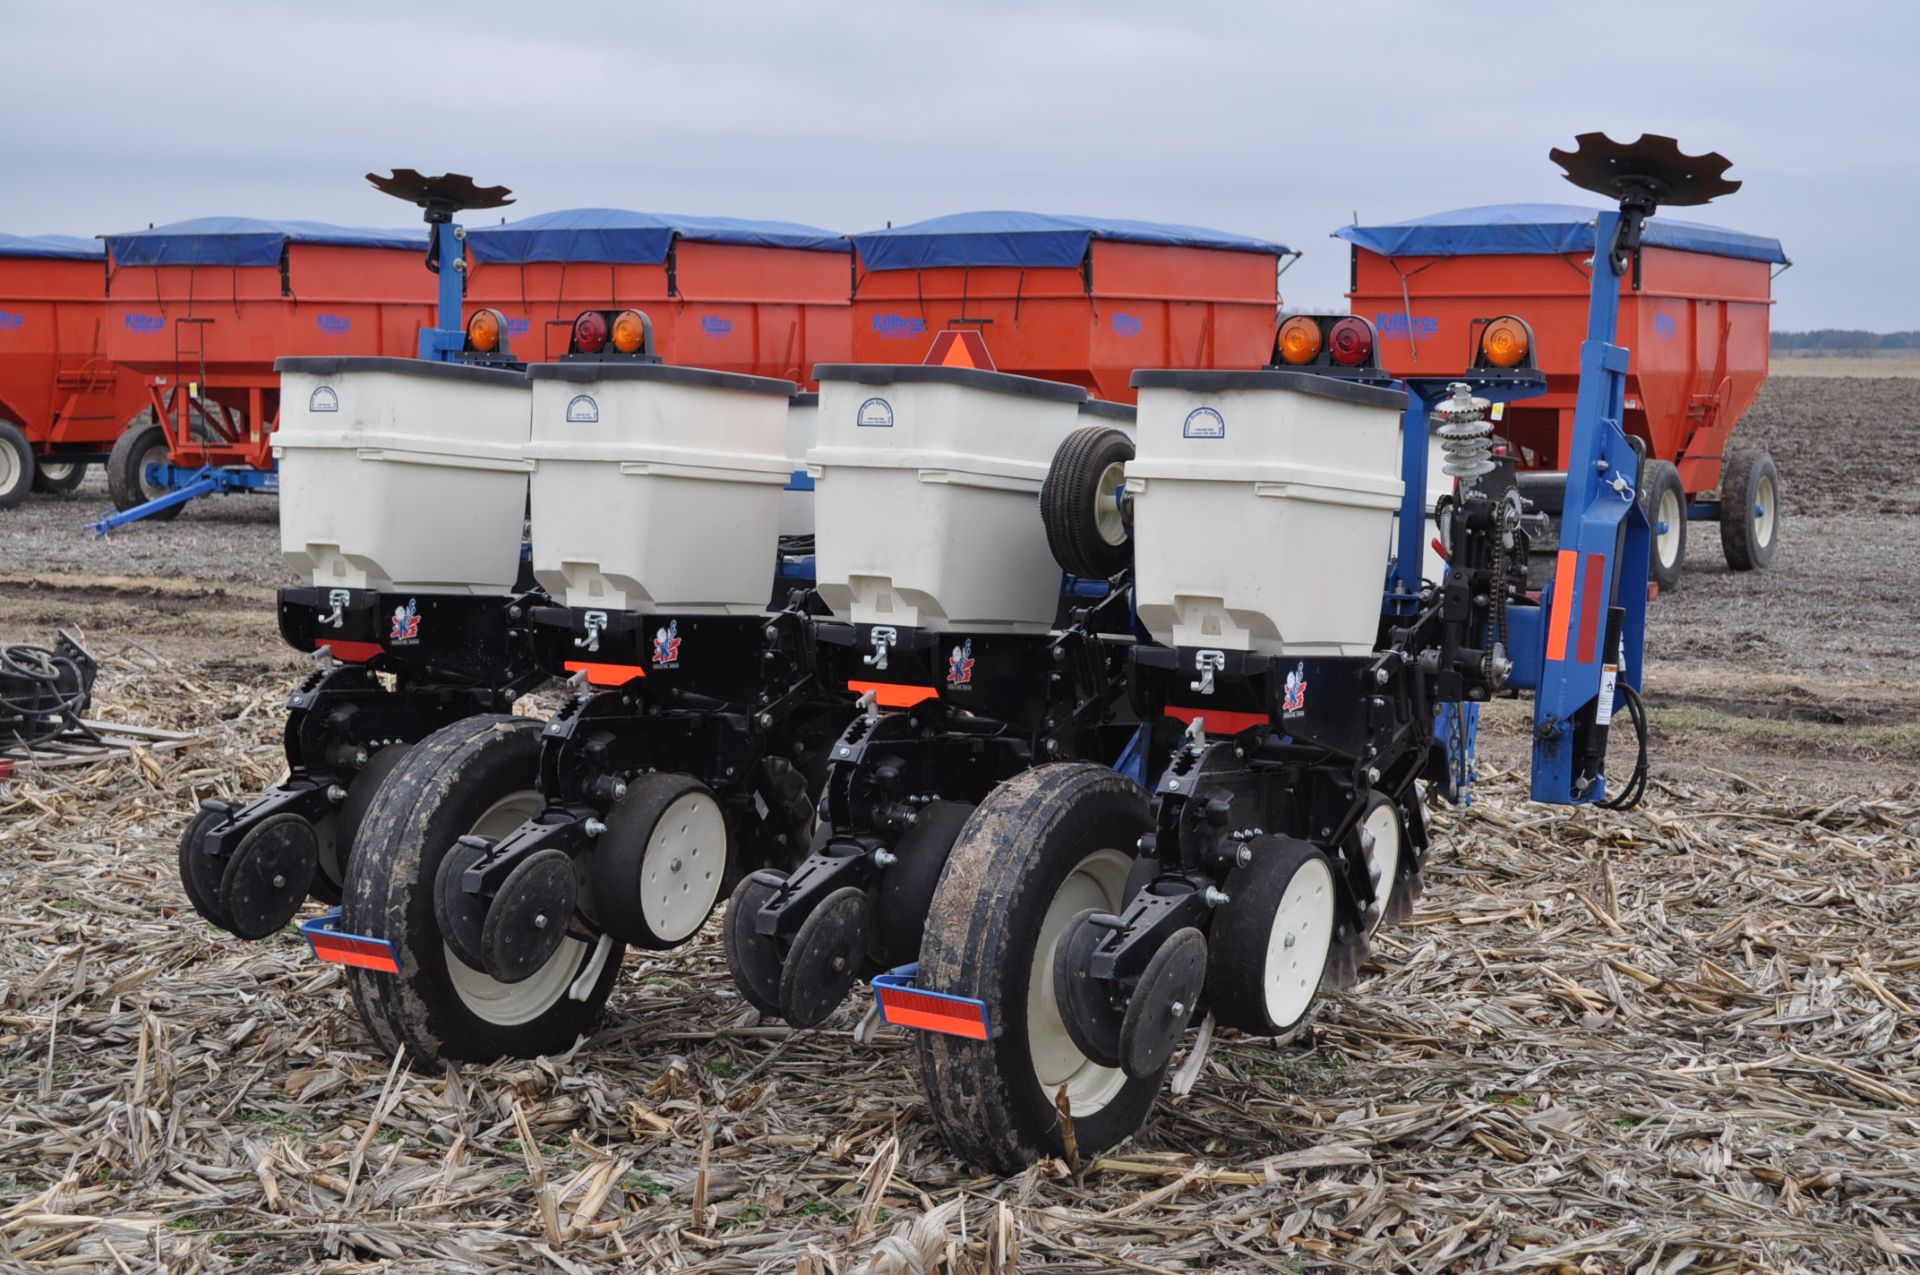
[0, 369, 1920, 1275]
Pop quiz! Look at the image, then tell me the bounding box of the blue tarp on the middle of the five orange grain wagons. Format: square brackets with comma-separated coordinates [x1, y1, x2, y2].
[467, 207, 847, 265]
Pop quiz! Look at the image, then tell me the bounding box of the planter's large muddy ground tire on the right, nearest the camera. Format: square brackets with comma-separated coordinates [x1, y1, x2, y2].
[918, 762, 1162, 1173]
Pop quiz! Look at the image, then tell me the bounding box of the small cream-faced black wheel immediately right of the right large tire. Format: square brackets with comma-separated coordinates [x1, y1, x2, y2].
[1206, 837, 1336, 1035]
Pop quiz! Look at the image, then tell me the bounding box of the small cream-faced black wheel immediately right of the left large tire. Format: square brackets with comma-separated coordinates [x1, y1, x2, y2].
[589, 774, 728, 949]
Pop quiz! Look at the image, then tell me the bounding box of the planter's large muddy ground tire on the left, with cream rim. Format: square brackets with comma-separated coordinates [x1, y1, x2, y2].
[342, 714, 624, 1066]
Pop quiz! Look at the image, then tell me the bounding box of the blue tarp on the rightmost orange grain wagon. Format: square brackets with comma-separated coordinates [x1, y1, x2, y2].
[1334, 204, 1788, 265]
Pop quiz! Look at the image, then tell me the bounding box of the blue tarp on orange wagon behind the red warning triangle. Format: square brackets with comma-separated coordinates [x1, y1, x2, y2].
[852, 213, 1290, 271]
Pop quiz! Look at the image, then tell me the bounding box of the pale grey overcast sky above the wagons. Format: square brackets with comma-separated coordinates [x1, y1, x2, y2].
[0, 0, 1920, 330]
